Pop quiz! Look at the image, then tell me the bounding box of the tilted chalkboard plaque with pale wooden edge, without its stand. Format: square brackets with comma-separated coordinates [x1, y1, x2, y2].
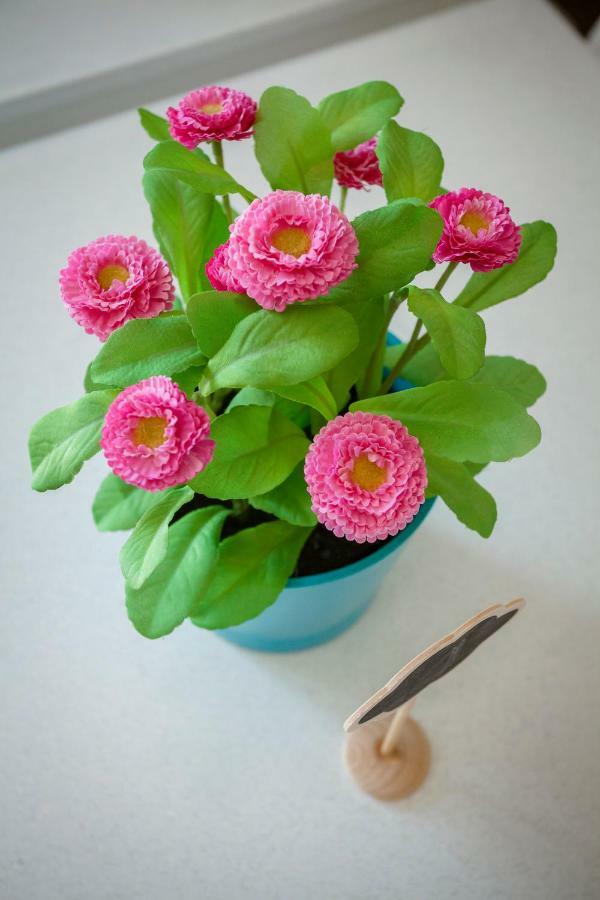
[344, 600, 524, 731]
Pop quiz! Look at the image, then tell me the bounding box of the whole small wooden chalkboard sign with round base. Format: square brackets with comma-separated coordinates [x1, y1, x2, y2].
[344, 600, 525, 800]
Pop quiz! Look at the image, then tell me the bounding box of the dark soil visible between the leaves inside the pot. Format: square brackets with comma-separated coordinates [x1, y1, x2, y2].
[175, 494, 390, 576]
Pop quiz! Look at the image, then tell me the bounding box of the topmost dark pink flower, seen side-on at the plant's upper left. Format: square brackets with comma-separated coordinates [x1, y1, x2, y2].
[167, 85, 256, 150]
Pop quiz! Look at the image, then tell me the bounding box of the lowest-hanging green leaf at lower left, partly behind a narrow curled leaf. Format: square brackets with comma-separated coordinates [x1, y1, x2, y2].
[125, 506, 229, 638]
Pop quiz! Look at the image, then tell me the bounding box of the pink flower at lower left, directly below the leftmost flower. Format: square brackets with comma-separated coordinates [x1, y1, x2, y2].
[100, 375, 215, 491]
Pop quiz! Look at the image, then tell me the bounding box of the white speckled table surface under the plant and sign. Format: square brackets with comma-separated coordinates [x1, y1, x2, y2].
[0, 0, 600, 900]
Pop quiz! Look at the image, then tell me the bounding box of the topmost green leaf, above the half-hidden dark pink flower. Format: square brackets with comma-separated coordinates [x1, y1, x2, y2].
[319, 81, 404, 153]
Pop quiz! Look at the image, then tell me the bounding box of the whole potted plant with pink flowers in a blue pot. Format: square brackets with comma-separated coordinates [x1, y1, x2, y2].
[29, 82, 556, 650]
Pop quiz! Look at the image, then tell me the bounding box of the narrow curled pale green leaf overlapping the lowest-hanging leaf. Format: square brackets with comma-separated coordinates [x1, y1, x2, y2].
[119, 485, 194, 588]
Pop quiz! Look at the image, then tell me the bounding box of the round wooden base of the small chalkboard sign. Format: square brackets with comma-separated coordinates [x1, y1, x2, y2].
[344, 716, 431, 800]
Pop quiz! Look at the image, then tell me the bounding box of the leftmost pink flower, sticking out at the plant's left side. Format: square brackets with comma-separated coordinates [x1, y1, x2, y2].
[60, 234, 175, 341]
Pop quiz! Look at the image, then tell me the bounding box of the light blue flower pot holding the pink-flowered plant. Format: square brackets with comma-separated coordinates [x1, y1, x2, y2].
[217, 334, 435, 653]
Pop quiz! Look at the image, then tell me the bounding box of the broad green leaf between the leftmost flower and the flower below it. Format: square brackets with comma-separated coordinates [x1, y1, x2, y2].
[90, 313, 204, 387]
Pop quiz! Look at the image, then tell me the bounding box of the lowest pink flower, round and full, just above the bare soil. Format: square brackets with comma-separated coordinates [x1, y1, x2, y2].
[304, 412, 427, 544]
